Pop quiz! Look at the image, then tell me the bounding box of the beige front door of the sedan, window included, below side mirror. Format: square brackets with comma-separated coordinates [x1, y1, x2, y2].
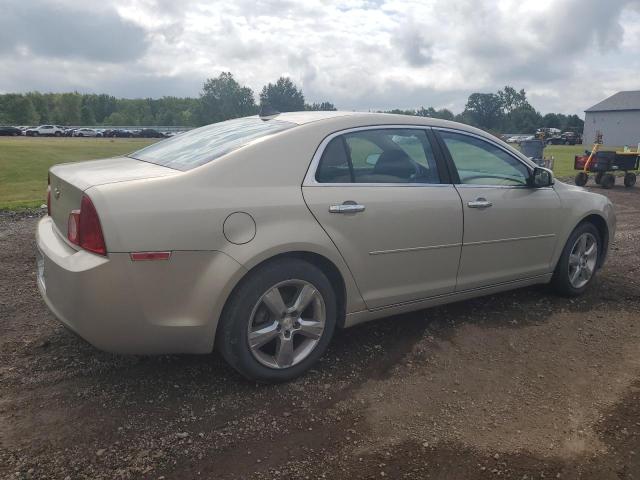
[436, 129, 561, 291]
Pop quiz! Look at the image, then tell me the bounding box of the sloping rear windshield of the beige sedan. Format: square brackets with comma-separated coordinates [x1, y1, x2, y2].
[128, 117, 296, 171]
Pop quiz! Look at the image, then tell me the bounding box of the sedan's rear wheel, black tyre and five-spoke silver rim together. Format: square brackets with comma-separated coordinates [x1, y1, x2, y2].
[216, 258, 336, 382]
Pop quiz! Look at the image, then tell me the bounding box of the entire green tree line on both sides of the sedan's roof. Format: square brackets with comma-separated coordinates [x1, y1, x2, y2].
[0, 72, 584, 133]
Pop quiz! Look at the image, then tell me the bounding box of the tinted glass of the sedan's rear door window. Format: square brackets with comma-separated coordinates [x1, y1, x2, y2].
[316, 128, 440, 183]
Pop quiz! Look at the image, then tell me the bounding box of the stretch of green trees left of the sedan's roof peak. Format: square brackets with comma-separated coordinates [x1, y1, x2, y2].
[0, 72, 336, 127]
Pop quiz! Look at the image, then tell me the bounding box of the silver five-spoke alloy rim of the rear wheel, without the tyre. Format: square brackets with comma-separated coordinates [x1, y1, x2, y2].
[247, 280, 326, 369]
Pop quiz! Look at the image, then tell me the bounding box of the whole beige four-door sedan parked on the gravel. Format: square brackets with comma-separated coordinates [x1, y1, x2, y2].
[37, 112, 615, 382]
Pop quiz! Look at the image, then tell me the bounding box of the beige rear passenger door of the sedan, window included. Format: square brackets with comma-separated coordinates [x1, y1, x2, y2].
[303, 126, 462, 309]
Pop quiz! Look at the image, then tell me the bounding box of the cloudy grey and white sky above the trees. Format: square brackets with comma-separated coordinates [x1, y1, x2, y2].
[0, 0, 640, 114]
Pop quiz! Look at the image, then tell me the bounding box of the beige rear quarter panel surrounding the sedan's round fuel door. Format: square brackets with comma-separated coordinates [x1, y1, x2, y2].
[87, 127, 365, 328]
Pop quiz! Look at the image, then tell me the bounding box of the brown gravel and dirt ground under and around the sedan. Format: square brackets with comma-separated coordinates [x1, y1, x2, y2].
[0, 187, 640, 479]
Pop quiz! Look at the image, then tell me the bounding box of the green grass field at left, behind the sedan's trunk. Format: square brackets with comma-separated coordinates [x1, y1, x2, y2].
[0, 137, 155, 209]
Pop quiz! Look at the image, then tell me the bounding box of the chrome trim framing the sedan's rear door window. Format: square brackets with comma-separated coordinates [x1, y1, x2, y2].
[302, 124, 453, 187]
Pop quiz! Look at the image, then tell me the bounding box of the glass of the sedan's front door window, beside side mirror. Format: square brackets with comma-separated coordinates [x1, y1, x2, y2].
[440, 132, 529, 186]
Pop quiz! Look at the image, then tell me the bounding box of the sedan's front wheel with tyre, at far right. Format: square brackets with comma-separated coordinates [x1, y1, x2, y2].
[551, 222, 602, 296]
